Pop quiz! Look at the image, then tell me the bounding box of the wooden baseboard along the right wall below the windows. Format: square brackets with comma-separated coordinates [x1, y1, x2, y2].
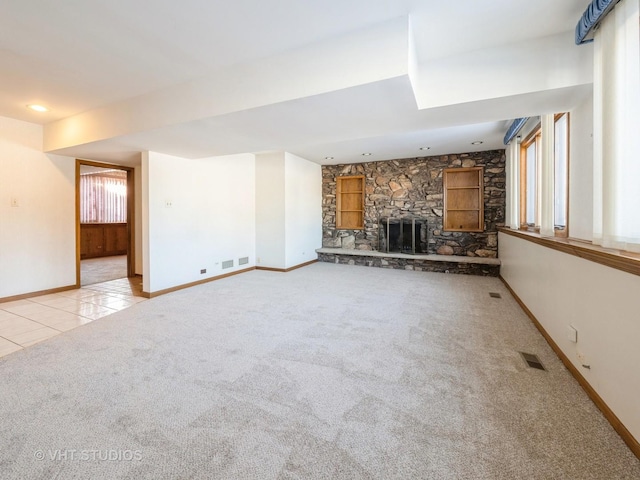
[499, 275, 640, 459]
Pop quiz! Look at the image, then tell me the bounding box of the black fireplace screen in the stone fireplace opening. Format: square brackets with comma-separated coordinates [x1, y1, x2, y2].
[378, 217, 427, 254]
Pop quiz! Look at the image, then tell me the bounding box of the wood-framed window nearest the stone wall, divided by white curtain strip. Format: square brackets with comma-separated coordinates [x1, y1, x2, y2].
[520, 113, 569, 236]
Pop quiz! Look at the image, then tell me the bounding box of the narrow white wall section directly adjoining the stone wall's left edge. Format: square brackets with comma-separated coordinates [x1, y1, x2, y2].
[284, 152, 322, 268]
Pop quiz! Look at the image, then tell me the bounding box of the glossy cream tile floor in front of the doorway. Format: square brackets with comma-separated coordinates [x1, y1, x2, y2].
[0, 277, 147, 357]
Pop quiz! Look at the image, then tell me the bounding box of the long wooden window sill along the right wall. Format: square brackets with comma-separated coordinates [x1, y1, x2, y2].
[498, 227, 640, 275]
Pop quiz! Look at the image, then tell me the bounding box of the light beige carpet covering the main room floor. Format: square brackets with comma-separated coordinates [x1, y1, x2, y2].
[0, 263, 640, 480]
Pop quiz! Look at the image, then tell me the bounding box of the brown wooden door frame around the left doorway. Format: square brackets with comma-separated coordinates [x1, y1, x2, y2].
[76, 158, 136, 288]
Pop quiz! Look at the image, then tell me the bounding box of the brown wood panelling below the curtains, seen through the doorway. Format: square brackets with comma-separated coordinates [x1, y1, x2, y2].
[80, 223, 129, 259]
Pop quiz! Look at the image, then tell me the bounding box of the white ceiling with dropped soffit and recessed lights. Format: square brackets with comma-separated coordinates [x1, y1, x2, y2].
[0, 0, 590, 163]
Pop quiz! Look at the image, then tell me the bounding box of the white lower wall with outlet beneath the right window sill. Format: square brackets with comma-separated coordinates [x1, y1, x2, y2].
[499, 233, 640, 446]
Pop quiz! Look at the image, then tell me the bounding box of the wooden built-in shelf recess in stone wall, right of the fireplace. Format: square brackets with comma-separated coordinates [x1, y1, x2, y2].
[442, 167, 484, 232]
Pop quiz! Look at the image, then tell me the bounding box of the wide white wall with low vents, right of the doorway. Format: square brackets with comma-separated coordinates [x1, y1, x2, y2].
[142, 152, 256, 293]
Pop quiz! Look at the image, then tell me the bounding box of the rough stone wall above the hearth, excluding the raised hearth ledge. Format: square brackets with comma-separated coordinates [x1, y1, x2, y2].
[322, 150, 506, 258]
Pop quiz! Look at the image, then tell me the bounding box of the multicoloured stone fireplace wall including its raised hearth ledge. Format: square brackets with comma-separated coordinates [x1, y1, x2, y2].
[318, 150, 506, 275]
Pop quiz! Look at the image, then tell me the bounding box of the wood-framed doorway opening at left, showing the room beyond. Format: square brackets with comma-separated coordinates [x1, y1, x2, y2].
[76, 159, 135, 288]
